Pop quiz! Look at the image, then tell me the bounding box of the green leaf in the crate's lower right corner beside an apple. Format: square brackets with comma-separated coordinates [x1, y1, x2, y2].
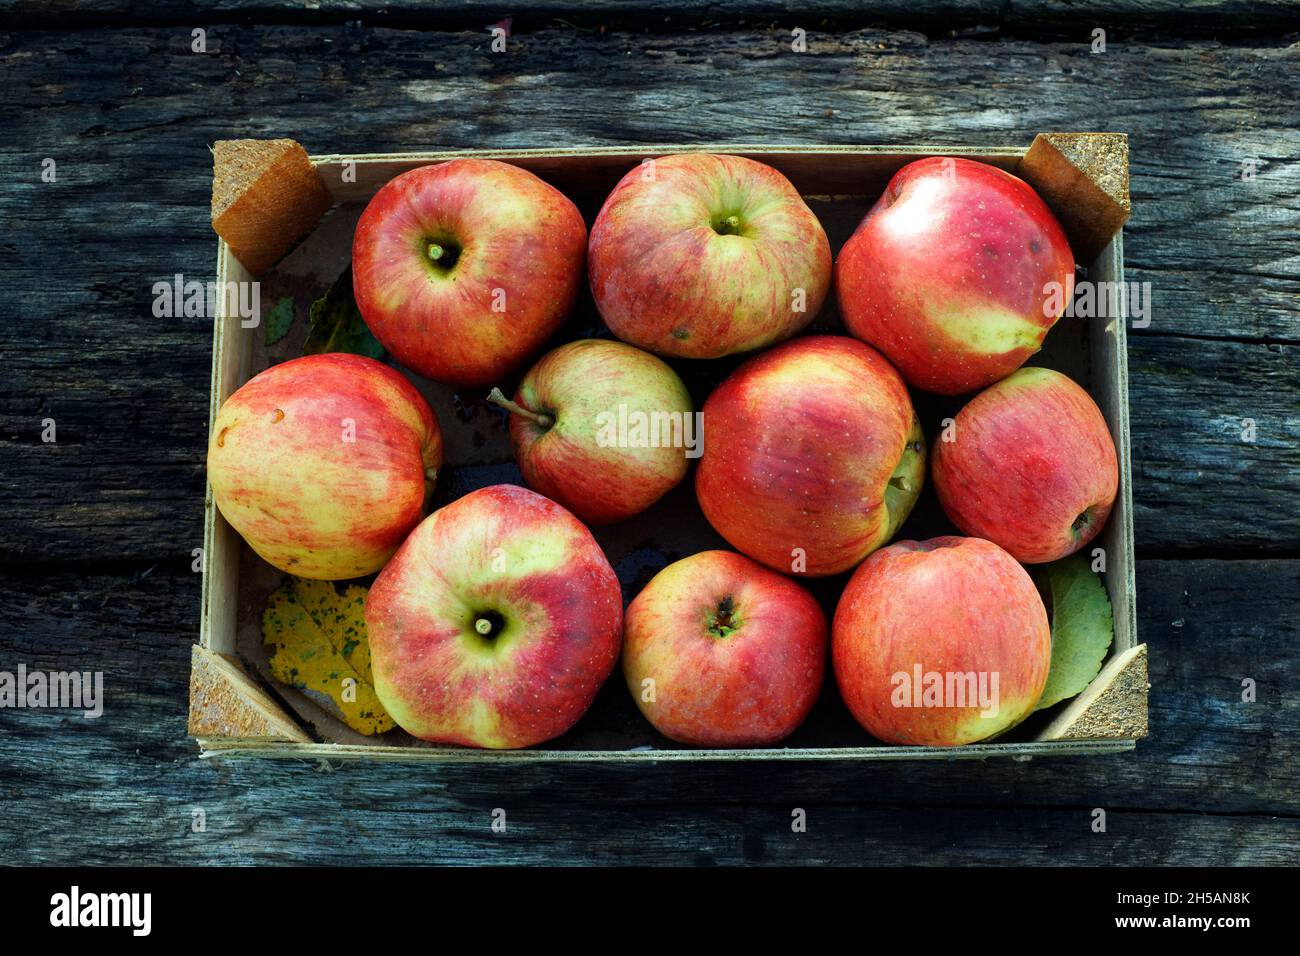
[1037, 554, 1115, 710]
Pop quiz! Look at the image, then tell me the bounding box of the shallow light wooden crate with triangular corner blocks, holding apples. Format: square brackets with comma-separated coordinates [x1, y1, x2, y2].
[190, 134, 1148, 762]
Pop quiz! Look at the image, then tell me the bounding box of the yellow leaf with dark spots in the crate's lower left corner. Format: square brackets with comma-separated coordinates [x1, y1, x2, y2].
[261, 578, 397, 736]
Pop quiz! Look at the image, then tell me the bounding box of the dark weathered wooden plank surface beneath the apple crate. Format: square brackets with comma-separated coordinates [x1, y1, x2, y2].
[0, 0, 1300, 864]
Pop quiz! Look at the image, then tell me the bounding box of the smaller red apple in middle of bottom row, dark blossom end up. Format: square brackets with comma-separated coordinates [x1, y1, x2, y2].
[623, 551, 828, 747]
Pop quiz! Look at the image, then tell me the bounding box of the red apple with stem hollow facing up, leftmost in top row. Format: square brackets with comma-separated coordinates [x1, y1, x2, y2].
[352, 159, 586, 385]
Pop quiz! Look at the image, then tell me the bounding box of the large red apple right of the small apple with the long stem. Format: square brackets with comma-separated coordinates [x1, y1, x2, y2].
[696, 336, 926, 575]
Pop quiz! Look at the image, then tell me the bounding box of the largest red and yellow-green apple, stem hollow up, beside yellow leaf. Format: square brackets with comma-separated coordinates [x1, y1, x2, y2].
[365, 485, 623, 749]
